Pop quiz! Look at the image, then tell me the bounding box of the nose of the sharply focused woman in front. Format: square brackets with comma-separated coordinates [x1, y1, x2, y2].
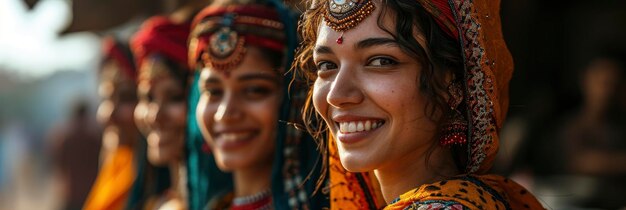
[326, 65, 363, 108]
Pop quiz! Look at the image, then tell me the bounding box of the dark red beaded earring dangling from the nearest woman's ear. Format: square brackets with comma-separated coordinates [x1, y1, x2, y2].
[439, 83, 467, 147]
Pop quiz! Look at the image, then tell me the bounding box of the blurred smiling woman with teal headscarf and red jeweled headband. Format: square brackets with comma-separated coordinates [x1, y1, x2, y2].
[188, 1, 327, 209]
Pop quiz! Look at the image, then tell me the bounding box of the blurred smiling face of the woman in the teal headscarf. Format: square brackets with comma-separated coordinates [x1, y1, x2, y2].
[197, 48, 282, 171]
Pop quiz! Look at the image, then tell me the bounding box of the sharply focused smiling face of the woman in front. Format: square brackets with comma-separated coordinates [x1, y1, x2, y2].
[313, 2, 435, 171]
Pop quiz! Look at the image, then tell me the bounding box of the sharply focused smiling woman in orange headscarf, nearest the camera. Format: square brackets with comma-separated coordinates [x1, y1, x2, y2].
[296, 0, 543, 209]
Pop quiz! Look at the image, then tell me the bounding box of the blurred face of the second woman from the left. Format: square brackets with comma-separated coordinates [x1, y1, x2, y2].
[135, 59, 187, 166]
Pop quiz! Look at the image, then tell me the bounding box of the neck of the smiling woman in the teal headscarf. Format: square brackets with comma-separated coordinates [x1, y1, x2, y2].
[233, 163, 272, 197]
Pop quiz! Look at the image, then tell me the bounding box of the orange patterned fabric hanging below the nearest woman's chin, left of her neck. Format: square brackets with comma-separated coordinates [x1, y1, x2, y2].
[328, 136, 385, 209]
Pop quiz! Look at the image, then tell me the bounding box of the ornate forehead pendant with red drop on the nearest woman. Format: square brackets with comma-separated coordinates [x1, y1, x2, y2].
[324, 0, 376, 44]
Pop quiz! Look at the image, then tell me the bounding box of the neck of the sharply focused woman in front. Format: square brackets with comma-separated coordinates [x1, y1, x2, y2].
[374, 147, 458, 203]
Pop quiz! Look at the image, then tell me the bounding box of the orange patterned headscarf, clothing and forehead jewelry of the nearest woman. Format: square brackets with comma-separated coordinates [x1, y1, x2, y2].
[319, 0, 544, 210]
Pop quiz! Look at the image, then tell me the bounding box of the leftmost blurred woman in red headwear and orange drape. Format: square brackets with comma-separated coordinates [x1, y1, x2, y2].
[83, 38, 140, 210]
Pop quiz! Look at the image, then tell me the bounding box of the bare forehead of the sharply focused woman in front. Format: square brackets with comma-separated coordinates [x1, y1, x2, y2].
[315, 0, 395, 47]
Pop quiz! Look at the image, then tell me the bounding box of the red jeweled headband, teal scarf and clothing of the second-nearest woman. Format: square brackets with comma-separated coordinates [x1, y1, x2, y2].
[189, 0, 328, 209]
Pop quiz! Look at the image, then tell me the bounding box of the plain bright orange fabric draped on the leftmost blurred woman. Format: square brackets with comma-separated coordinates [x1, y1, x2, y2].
[83, 146, 136, 210]
